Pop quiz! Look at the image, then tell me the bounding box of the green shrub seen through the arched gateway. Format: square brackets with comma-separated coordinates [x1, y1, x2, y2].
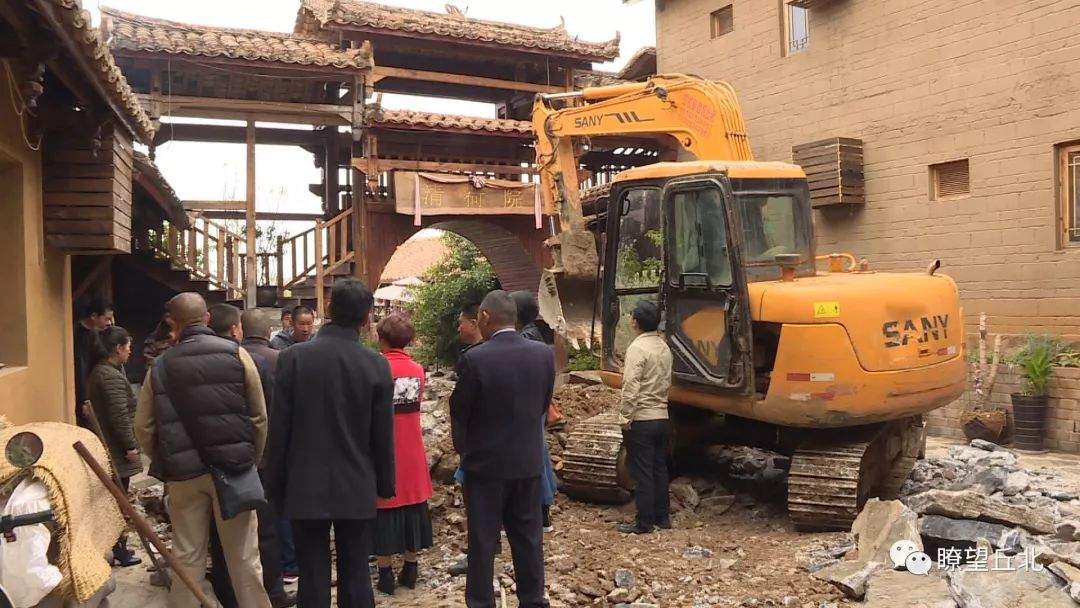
[409, 232, 499, 366]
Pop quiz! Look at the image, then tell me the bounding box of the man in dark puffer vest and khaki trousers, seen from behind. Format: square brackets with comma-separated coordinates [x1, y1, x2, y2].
[135, 293, 270, 608]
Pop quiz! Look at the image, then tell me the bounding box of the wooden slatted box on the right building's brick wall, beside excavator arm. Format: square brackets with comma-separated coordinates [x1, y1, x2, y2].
[792, 137, 866, 207]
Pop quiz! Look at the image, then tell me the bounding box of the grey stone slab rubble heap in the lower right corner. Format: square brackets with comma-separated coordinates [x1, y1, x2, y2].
[812, 440, 1080, 608]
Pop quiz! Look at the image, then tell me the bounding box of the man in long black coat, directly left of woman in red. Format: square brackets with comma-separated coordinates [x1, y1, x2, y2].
[266, 279, 394, 608]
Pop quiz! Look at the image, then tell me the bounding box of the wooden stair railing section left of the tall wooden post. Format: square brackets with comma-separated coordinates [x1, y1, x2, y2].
[150, 217, 246, 299]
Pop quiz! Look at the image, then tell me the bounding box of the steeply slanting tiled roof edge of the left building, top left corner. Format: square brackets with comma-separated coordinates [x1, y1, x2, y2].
[50, 0, 154, 143]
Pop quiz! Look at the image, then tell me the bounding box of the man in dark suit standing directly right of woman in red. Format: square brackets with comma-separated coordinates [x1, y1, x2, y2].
[451, 291, 555, 608]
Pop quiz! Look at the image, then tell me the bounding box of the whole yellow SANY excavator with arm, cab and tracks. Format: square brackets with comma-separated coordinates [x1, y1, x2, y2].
[532, 75, 966, 529]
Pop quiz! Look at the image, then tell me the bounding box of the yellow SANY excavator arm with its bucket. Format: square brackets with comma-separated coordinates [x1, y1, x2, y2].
[532, 75, 753, 344]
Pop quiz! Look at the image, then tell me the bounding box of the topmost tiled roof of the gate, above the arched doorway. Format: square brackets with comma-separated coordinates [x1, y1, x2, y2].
[296, 0, 619, 62]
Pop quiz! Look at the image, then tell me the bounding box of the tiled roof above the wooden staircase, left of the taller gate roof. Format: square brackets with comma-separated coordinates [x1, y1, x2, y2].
[102, 6, 372, 69]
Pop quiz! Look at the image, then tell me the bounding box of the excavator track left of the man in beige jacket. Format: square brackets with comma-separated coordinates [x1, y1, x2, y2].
[559, 414, 630, 503]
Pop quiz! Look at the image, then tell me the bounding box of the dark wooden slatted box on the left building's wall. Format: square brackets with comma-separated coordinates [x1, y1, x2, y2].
[43, 127, 133, 254]
